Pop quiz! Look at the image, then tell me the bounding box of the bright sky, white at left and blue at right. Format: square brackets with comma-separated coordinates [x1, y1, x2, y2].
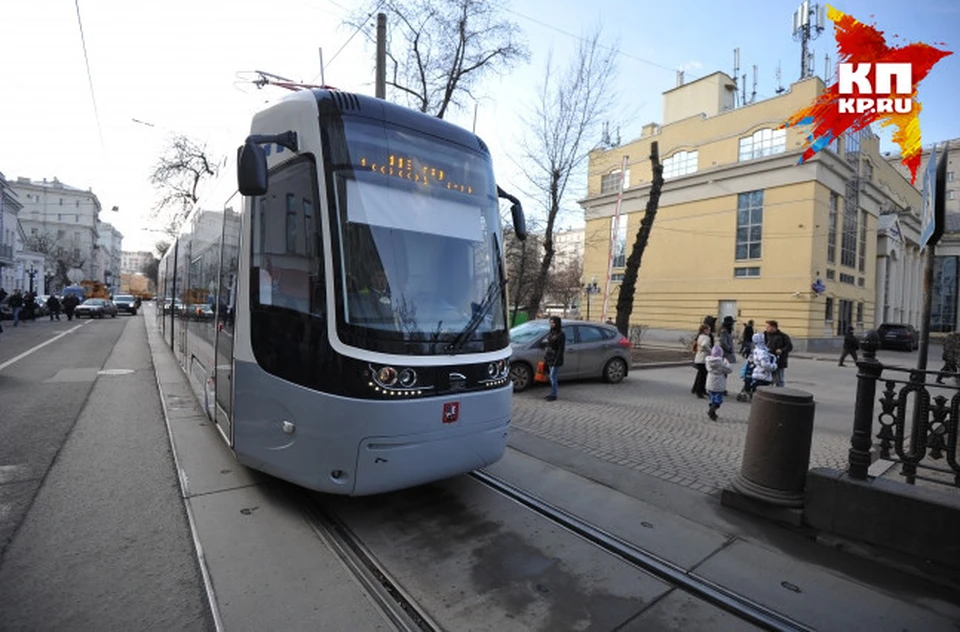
[0, 0, 960, 250]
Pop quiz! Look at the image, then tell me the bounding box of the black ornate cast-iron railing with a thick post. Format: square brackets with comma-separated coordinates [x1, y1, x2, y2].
[847, 331, 960, 487]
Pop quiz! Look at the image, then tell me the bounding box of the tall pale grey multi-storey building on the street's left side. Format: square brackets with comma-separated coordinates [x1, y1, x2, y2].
[9, 178, 104, 291]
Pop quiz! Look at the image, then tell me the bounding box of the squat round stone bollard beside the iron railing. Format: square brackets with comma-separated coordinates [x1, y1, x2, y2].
[731, 387, 816, 507]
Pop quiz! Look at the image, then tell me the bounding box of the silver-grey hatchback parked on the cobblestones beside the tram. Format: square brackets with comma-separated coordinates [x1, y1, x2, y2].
[510, 320, 631, 391]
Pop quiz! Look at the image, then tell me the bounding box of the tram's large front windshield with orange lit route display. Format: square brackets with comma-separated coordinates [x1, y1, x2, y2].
[328, 117, 506, 354]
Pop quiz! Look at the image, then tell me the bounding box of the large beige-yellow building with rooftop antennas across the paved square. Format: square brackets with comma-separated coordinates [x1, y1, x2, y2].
[581, 72, 921, 349]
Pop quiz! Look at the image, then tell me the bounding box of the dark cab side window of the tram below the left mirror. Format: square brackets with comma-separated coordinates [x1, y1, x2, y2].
[251, 158, 326, 316]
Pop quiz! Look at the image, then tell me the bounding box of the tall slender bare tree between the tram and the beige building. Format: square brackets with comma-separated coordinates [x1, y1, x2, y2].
[519, 29, 617, 313]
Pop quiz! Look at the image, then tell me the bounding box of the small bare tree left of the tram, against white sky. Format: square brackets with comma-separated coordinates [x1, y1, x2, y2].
[150, 135, 220, 238]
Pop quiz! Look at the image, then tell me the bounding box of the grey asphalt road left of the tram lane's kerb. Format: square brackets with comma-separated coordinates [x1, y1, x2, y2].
[0, 316, 213, 630]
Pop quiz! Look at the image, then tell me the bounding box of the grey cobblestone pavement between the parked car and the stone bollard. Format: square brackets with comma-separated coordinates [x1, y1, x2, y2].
[513, 359, 855, 494]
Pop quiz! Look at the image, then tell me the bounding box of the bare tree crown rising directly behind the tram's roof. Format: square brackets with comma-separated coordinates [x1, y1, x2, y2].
[346, 0, 528, 118]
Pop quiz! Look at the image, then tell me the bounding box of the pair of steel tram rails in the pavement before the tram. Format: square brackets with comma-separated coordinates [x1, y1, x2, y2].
[298, 470, 813, 632]
